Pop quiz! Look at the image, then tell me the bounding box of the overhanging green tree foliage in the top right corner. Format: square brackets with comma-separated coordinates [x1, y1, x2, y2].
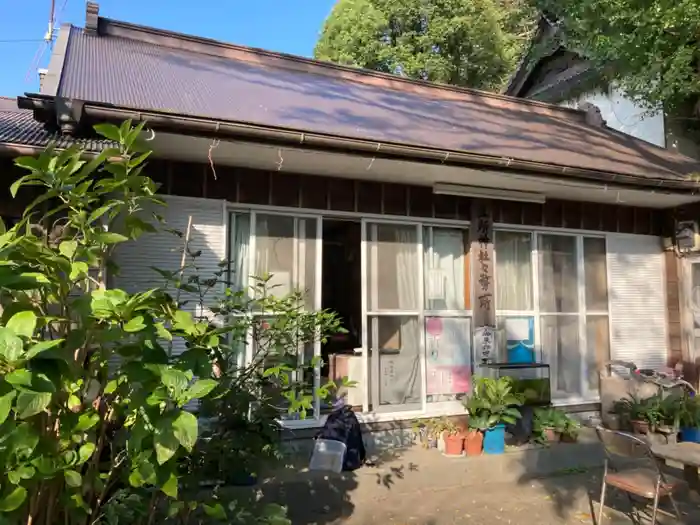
[536, 0, 700, 112]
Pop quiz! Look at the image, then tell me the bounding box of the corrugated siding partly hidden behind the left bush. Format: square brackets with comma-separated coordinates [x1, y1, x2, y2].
[112, 197, 226, 354]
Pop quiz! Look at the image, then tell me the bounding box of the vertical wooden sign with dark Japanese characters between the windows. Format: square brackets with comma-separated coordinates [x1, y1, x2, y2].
[470, 199, 497, 363]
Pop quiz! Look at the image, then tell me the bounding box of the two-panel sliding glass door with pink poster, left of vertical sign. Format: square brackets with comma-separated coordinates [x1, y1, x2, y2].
[363, 221, 472, 412]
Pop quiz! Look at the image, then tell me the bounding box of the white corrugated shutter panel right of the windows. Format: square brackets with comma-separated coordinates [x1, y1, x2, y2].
[607, 235, 668, 368]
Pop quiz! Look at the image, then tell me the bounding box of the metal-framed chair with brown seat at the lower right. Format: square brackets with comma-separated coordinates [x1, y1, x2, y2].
[596, 427, 683, 525]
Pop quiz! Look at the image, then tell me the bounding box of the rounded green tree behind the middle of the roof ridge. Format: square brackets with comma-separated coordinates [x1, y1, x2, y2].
[314, 0, 534, 90]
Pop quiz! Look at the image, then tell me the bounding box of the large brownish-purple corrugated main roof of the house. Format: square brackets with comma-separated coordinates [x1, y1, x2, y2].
[59, 23, 700, 180]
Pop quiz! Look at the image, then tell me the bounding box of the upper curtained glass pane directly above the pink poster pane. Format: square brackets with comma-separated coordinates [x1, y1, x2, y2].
[423, 227, 469, 310]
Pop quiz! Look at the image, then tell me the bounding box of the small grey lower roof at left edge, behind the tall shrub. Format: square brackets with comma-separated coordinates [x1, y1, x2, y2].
[0, 97, 113, 152]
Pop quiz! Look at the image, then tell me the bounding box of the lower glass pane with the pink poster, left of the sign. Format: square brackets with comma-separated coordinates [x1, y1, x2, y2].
[425, 317, 472, 403]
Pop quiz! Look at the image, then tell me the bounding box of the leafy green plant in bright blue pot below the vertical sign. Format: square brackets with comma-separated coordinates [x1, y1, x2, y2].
[464, 376, 523, 454]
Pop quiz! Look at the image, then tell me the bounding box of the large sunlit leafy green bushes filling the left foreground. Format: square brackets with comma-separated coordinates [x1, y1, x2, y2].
[0, 122, 339, 525]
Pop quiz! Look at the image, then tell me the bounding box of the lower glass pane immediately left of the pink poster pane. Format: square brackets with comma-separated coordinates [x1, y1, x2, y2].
[368, 316, 422, 410]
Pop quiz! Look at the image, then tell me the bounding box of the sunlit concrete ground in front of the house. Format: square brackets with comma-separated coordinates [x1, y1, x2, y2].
[231, 435, 700, 525]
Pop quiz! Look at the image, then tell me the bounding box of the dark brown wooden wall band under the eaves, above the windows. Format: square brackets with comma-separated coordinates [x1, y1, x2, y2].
[149, 160, 665, 235]
